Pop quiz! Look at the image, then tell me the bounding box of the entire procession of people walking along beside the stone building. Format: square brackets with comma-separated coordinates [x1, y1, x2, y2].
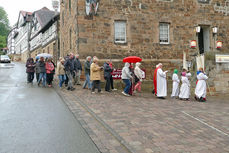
[26, 53, 208, 102]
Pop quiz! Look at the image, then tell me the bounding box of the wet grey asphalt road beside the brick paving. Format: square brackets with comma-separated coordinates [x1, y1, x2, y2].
[0, 63, 99, 153]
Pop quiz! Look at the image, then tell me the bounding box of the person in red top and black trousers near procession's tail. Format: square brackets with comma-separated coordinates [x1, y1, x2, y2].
[45, 58, 55, 87]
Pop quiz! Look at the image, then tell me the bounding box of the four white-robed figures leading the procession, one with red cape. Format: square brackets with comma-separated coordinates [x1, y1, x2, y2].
[151, 63, 208, 102]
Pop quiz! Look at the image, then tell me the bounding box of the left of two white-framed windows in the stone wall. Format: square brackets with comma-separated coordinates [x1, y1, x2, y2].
[114, 21, 126, 43]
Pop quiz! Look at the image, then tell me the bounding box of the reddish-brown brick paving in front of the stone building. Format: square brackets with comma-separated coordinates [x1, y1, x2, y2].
[57, 86, 229, 153]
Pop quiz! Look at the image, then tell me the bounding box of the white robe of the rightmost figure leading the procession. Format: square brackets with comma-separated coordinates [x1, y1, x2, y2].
[195, 73, 208, 98]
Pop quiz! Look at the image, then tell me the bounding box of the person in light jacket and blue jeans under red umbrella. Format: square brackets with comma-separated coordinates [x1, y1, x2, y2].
[121, 63, 133, 96]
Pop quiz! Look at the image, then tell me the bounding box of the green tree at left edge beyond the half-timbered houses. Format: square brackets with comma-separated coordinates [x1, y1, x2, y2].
[0, 7, 10, 36]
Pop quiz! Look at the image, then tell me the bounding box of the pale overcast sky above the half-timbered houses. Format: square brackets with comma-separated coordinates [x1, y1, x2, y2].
[0, 0, 57, 26]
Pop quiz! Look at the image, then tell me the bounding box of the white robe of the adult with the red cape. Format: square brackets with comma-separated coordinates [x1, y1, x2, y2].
[157, 68, 167, 97]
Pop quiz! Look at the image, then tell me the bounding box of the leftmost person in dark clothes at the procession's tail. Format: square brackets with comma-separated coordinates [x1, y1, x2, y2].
[26, 58, 35, 83]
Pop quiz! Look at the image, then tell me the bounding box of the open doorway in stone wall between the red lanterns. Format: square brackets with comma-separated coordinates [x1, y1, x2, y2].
[198, 26, 210, 54]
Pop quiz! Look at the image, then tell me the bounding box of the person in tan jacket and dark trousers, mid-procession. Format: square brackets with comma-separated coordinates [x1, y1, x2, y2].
[90, 57, 103, 93]
